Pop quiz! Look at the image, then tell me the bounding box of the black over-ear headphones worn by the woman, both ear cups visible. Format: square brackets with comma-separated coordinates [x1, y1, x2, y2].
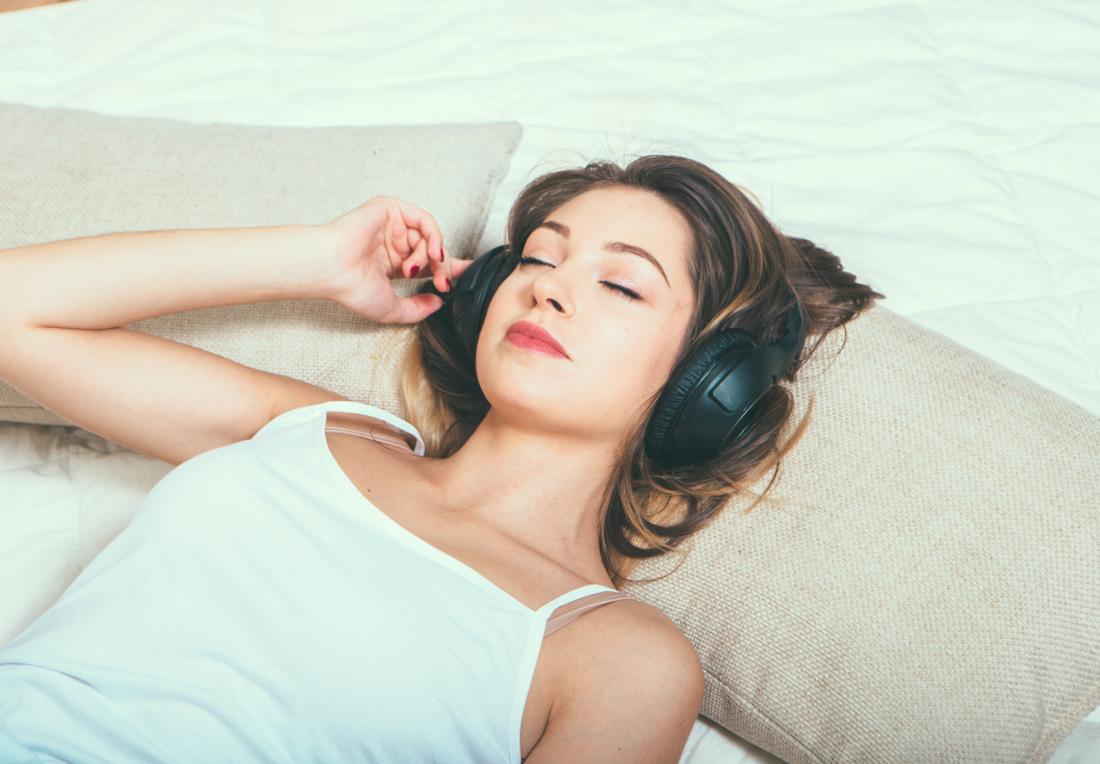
[429, 244, 805, 465]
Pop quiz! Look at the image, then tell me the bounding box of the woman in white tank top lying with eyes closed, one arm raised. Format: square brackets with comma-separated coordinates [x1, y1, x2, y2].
[0, 156, 882, 762]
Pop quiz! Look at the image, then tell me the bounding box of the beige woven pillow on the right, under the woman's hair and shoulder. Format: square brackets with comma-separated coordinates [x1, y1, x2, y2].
[638, 306, 1100, 764]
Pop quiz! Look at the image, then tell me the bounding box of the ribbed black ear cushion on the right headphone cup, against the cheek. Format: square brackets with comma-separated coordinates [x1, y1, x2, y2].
[646, 328, 758, 462]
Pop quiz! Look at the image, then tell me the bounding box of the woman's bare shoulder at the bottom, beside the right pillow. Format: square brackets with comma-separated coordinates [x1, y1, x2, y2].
[526, 599, 705, 764]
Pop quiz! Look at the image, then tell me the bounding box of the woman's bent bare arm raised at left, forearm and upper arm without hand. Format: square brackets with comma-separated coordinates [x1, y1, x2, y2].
[0, 225, 342, 464]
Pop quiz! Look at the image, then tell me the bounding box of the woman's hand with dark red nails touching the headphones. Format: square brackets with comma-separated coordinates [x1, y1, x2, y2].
[322, 196, 473, 323]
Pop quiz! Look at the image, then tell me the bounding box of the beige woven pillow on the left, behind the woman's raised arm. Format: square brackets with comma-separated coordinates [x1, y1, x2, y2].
[0, 103, 523, 424]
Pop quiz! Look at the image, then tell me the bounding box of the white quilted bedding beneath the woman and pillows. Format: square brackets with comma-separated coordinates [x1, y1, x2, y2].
[0, 0, 1100, 764]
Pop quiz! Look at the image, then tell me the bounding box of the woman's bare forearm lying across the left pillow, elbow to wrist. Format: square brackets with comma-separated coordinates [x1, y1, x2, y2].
[0, 220, 336, 329]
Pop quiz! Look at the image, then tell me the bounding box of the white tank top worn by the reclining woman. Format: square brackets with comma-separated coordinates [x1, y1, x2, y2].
[0, 401, 627, 764]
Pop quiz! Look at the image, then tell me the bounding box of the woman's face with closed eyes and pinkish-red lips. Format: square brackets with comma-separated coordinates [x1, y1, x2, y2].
[476, 187, 693, 442]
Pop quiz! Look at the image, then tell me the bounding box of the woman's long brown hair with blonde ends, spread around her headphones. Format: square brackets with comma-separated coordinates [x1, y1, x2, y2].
[400, 154, 884, 588]
